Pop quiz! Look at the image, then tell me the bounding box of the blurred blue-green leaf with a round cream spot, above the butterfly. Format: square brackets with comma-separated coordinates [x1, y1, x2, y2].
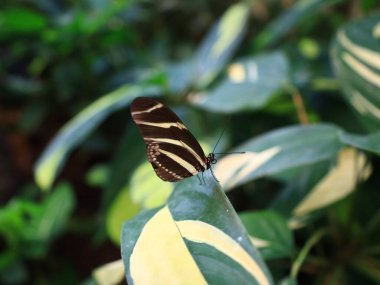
[191, 52, 289, 113]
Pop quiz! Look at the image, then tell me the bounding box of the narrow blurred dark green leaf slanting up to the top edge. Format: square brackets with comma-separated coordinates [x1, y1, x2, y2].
[254, 0, 341, 49]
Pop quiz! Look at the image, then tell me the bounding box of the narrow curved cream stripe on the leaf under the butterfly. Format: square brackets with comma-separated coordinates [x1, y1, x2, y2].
[176, 220, 270, 285]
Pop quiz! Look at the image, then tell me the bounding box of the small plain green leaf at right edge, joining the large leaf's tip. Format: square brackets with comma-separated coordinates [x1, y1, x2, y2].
[339, 132, 380, 155]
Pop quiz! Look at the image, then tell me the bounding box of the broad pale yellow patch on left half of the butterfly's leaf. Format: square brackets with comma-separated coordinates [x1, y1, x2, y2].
[129, 207, 207, 285]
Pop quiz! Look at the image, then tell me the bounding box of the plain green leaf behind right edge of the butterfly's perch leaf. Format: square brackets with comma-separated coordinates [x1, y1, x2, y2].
[239, 211, 294, 259]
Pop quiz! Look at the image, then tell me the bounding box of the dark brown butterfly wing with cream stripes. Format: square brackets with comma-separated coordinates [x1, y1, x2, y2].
[131, 97, 208, 182]
